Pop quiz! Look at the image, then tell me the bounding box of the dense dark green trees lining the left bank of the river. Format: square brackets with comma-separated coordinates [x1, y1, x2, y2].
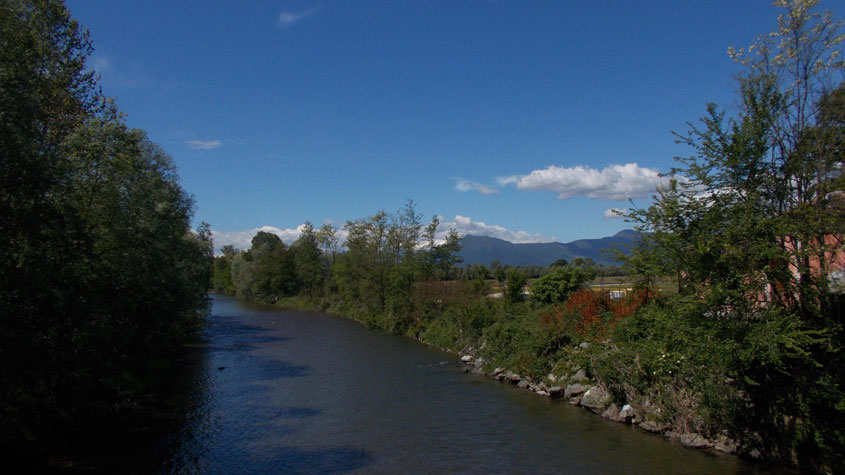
[0, 0, 211, 449]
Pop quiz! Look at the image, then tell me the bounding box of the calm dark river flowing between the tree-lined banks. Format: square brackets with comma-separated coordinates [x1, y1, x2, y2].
[142, 296, 753, 474]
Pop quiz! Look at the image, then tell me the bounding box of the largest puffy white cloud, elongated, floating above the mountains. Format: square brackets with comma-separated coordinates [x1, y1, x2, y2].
[499, 163, 668, 200]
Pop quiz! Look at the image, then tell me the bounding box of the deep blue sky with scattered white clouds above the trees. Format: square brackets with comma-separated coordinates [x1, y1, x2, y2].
[68, 0, 796, 249]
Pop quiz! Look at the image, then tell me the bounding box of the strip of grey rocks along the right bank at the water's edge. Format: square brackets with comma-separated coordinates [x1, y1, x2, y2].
[460, 350, 740, 456]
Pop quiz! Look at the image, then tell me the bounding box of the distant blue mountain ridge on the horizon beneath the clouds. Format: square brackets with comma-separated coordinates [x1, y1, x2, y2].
[461, 229, 639, 266]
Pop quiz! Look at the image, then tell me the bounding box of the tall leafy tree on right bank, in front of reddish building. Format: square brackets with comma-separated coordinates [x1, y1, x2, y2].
[629, 0, 845, 471]
